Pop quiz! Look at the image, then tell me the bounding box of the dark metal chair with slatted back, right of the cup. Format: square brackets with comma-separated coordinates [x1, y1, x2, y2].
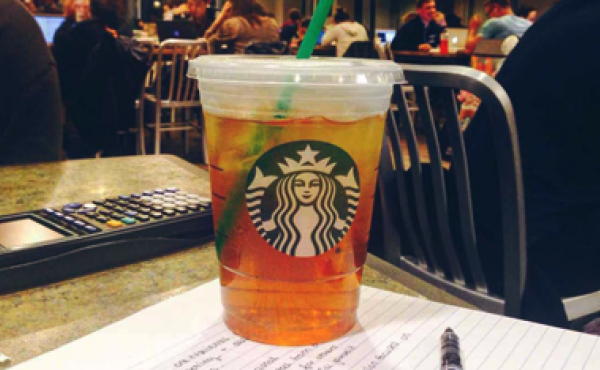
[374, 64, 600, 321]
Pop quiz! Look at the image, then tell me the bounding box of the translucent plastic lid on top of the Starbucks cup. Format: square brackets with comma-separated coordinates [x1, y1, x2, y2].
[188, 55, 405, 87]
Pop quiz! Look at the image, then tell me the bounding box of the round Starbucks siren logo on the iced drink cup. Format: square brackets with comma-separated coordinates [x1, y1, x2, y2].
[246, 141, 360, 257]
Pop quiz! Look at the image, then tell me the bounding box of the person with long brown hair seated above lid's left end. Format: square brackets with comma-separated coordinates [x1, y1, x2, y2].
[207, 0, 279, 54]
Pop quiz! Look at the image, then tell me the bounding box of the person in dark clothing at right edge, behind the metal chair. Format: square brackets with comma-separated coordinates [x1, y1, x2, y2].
[465, 0, 600, 326]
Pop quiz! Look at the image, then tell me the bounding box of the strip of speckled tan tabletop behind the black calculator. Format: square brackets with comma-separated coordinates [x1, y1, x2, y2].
[0, 155, 210, 215]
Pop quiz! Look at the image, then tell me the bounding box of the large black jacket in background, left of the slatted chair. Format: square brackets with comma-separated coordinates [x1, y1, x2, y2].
[54, 20, 147, 155]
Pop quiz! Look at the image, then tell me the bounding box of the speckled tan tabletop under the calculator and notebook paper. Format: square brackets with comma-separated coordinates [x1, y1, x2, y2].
[0, 156, 469, 368]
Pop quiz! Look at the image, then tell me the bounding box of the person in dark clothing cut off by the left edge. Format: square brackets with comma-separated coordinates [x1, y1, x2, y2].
[0, 0, 63, 165]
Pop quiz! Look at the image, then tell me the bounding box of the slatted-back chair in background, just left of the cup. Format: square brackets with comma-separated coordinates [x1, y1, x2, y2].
[138, 39, 208, 156]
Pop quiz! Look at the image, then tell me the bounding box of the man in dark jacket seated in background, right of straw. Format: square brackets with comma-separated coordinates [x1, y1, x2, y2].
[392, 0, 444, 51]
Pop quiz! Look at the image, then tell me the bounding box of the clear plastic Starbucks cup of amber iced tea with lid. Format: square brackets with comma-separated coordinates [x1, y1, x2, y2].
[189, 55, 404, 345]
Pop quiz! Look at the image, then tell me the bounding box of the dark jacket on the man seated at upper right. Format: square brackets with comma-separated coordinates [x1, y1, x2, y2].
[392, 17, 444, 51]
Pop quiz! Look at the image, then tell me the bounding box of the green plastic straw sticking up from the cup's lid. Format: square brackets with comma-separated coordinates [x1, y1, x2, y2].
[275, 0, 333, 115]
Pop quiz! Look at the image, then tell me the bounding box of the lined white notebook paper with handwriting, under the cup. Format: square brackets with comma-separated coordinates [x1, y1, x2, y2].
[14, 280, 600, 370]
